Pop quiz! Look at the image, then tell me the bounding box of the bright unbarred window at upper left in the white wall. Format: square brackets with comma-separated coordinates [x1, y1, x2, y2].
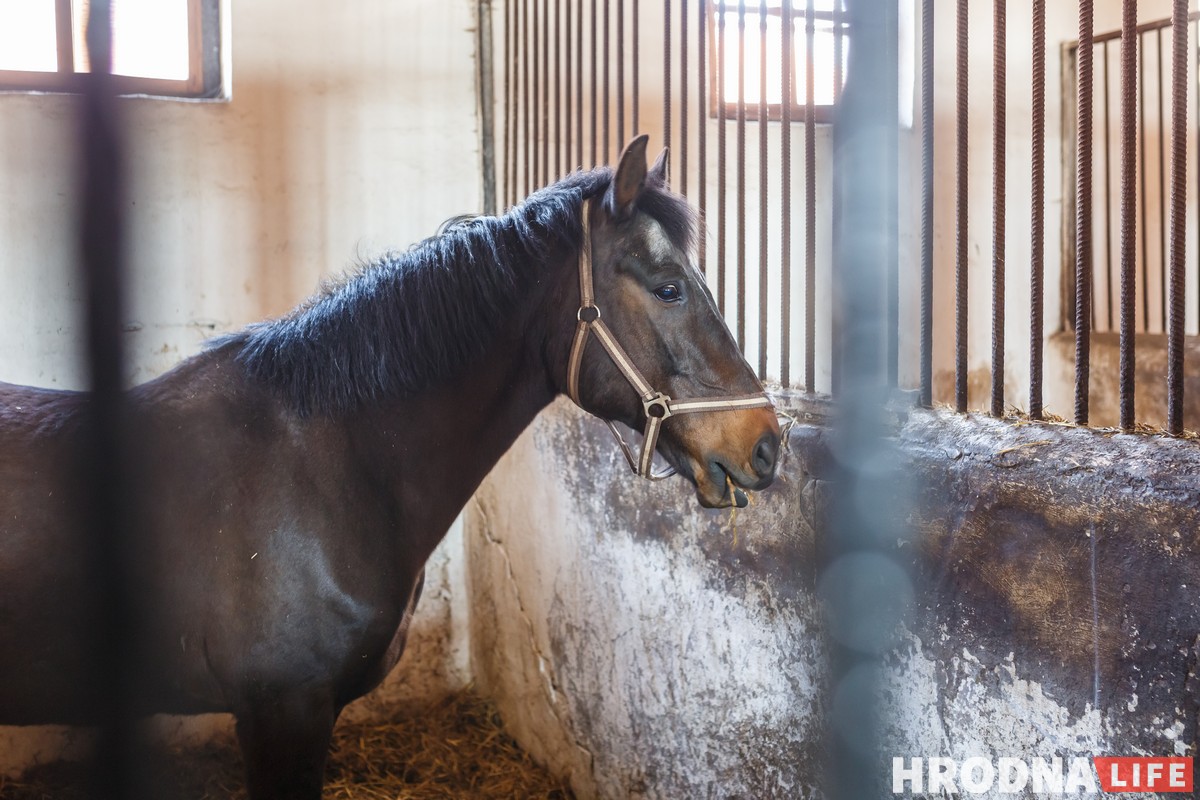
[0, 0, 227, 98]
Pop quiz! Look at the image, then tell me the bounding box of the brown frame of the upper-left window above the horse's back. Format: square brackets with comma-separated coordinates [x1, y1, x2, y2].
[0, 0, 228, 100]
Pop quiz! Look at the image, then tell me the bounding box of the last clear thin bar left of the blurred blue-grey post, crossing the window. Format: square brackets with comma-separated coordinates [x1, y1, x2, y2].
[806, 0, 817, 395]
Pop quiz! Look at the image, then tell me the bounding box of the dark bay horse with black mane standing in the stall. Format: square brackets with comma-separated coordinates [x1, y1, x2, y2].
[0, 137, 779, 800]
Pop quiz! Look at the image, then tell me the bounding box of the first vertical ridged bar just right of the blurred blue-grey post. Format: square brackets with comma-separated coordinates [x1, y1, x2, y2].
[919, 0, 931, 408]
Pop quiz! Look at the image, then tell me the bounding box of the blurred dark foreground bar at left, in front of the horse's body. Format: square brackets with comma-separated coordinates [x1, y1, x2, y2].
[74, 0, 138, 798]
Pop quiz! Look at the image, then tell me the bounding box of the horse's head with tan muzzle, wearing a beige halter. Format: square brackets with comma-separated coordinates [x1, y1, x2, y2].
[566, 136, 780, 507]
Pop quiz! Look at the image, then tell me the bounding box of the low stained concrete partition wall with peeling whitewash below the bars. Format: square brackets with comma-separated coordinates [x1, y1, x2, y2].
[467, 403, 1200, 799]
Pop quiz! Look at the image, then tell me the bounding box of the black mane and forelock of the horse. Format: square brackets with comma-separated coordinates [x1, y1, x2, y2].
[217, 168, 696, 415]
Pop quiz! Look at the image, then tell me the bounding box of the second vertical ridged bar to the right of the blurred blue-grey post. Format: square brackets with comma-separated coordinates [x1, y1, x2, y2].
[954, 0, 971, 411]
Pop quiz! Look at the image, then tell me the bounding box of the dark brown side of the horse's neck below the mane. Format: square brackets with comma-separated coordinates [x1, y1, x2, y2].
[347, 253, 577, 558]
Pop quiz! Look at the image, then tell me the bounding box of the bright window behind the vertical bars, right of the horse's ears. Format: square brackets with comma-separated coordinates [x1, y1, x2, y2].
[709, 0, 850, 122]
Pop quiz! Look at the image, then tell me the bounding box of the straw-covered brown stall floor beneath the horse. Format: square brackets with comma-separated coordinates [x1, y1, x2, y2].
[0, 693, 574, 800]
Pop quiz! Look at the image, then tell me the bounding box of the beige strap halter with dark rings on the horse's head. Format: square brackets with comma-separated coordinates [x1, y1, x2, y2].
[566, 200, 772, 481]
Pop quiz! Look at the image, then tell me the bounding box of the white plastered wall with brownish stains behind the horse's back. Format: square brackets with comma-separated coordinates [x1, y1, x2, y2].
[0, 0, 482, 774]
